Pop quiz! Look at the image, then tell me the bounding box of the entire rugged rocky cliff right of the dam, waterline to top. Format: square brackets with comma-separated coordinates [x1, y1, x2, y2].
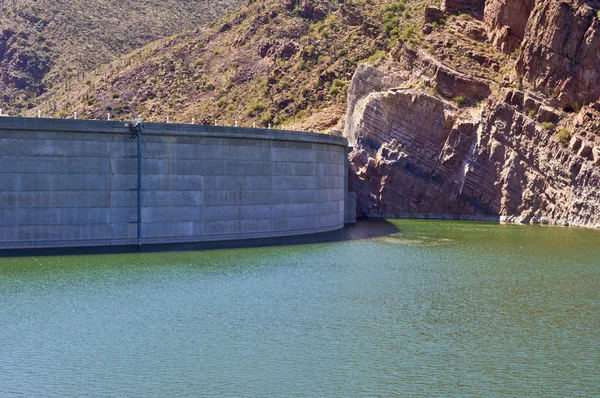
[343, 0, 600, 227]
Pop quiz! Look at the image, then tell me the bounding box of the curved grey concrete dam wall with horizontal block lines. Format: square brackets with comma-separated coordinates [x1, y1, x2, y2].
[0, 118, 351, 249]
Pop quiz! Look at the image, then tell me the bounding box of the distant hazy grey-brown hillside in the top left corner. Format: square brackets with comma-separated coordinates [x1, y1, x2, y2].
[0, 0, 241, 114]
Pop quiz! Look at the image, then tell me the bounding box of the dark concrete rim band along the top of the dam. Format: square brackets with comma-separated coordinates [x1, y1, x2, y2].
[0, 116, 348, 147]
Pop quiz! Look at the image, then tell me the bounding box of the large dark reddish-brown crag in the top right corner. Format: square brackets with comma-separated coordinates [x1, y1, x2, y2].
[517, 0, 600, 109]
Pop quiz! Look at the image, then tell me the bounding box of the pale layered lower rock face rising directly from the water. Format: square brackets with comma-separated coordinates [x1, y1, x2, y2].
[345, 65, 600, 226]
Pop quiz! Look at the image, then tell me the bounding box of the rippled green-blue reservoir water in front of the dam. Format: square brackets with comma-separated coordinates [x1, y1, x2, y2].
[0, 220, 600, 397]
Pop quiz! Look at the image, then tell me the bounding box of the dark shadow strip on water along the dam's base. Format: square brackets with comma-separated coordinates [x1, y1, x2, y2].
[0, 219, 399, 258]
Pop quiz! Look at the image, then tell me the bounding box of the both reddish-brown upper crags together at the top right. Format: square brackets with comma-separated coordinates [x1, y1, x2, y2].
[484, 0, 600, 110]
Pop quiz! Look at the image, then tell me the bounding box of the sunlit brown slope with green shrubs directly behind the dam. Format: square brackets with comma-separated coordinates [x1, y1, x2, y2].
[23, 0, 430, 131]
